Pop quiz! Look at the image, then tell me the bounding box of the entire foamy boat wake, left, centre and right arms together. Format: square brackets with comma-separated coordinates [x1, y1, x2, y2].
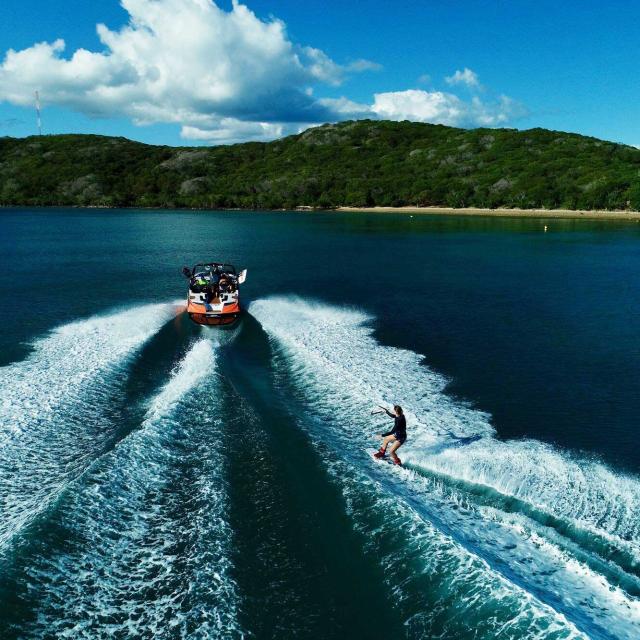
[0, 297, 640, 640]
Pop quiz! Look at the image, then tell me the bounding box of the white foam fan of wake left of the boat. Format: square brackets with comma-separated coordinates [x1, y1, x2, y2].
[0, 304, 175, 547]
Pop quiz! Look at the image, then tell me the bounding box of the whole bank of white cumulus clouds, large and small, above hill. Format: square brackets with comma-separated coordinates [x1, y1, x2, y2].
[0, 0, 523, 144]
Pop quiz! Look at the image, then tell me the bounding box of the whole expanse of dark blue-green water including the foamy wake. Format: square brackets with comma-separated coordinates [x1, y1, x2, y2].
[0, 209, 640, 639]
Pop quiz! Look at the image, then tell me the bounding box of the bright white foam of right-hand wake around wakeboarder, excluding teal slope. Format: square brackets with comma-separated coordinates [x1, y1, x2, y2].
[250, 298, 640, 638]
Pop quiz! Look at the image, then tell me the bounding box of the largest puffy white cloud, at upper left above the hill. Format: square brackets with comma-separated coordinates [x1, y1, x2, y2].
[0, 0, 375, 141]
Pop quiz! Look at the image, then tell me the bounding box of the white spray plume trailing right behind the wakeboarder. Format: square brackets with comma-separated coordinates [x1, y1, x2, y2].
[407, 439, 640, 552]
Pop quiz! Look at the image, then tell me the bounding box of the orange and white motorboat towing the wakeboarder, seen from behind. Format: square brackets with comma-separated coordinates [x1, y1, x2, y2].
[182, 262, 247, 327]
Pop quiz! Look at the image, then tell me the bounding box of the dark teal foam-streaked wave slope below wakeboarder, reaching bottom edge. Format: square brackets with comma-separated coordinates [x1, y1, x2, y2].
[328, 458, 586, 640]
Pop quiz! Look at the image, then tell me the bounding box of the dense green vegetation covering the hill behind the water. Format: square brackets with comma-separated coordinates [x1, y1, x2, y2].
[0, 120, 640, 210]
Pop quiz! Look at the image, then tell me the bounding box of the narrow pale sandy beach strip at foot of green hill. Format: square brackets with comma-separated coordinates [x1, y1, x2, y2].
[334, 207, 640, 221]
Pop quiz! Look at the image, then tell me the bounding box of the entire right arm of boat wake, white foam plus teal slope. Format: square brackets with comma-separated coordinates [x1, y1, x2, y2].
[250, 298, 640, 639]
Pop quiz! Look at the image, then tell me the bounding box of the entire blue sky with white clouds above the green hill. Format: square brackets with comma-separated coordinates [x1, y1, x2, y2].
[0, 0, 640, 145]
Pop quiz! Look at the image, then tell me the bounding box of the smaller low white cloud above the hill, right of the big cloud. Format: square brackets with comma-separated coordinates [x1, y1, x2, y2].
[371, 89, 524, 127]
